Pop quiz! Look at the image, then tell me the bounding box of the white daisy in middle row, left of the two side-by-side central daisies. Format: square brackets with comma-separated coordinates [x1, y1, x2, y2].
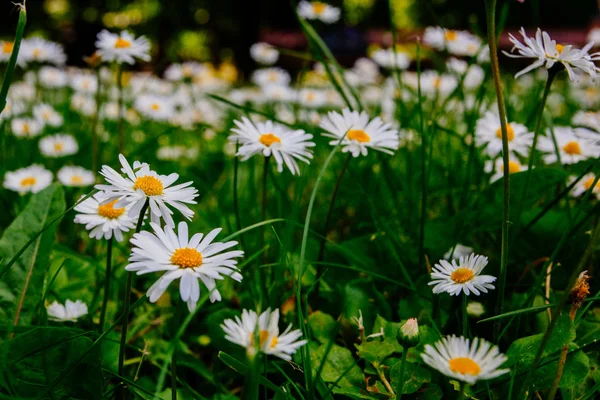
[229, 117, 315, 175]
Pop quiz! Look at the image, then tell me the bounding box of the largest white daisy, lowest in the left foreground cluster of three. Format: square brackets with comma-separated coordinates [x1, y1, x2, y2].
[125, 222, 244, 312]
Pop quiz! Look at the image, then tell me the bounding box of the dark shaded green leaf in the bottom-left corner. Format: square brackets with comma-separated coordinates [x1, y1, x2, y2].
[0, 328, 104, 399]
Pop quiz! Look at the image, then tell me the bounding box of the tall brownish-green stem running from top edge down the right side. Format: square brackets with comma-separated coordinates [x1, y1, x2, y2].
[485, 0, 510, 337]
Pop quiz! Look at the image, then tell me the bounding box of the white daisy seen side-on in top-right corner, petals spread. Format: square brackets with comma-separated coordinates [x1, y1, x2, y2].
[504, 28, 599, 81]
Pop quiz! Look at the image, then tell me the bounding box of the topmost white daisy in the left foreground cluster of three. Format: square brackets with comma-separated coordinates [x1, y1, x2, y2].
[96, 154, 198, 227]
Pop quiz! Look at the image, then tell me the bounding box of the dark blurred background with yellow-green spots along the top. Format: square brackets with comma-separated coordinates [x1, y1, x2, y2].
[0, 0, 600, 71]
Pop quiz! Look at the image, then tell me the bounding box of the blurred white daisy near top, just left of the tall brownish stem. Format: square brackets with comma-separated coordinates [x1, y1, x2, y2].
[423, 26, 482, 56]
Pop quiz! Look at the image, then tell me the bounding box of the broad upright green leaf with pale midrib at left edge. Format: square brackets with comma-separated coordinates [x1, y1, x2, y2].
[0, 184, 66, 325]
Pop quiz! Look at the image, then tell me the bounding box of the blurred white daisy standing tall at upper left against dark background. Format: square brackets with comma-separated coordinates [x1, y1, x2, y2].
[96, 30, 150, 64]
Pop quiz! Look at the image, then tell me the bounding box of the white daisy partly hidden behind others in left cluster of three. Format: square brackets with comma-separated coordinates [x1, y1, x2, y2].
[74, 193, 137, 242]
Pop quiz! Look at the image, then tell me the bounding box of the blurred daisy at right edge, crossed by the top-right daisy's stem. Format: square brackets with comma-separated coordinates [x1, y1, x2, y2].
[537, 127, 600, 164]
